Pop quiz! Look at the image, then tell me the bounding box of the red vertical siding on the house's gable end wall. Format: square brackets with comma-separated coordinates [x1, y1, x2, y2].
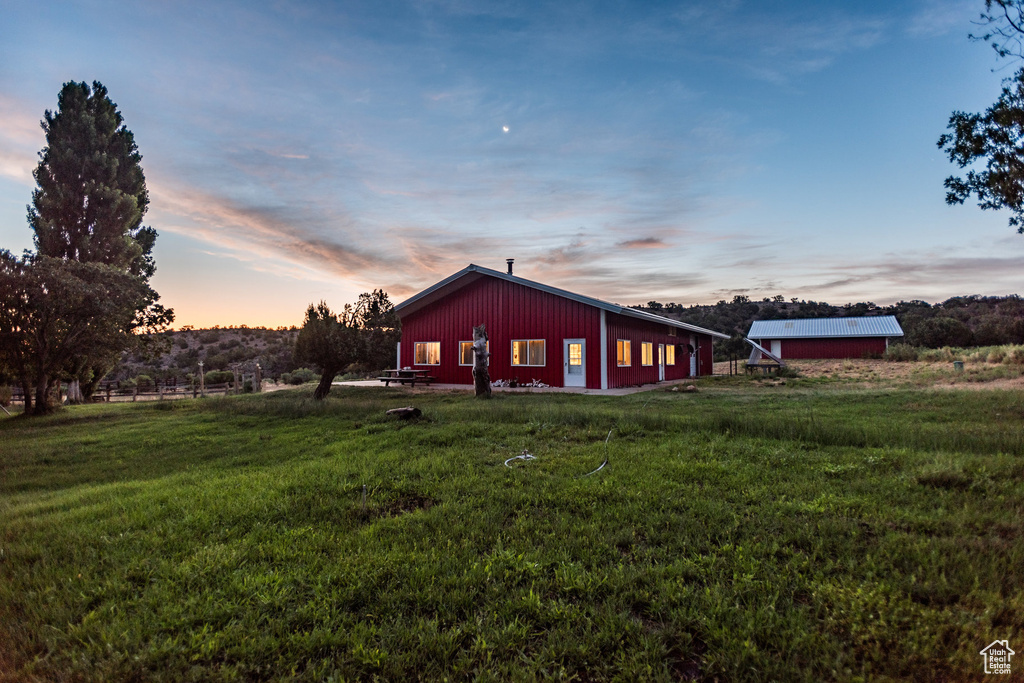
[401, 278, 602, 389]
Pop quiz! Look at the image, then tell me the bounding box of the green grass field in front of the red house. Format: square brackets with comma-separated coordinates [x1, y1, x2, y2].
[0, 377, 1024, 681]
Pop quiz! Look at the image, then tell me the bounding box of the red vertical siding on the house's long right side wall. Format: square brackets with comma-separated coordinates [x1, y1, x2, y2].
[602, 313, 713, 388]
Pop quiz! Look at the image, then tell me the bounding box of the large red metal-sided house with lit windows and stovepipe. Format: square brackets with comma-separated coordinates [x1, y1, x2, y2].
[395, 263, 728, 389]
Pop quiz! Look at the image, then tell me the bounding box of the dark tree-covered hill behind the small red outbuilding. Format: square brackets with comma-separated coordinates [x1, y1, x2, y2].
[634, 295, 1024, 357]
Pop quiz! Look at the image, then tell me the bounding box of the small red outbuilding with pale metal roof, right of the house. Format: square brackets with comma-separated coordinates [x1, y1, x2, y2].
[746, 315, 903, 359]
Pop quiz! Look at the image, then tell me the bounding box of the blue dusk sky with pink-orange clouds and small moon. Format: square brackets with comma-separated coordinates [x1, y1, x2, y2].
[0, 0, 1024, 327]
